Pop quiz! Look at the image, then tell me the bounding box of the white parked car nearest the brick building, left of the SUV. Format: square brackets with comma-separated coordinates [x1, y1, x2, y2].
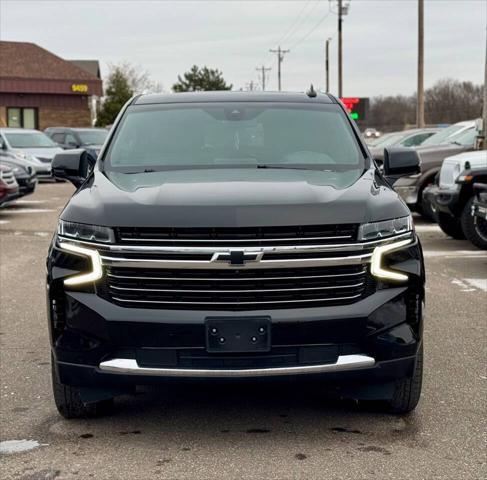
[0, 128, 63, 180]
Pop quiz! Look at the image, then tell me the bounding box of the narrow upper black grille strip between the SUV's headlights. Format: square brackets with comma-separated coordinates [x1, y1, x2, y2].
[116, 224, 358, 247]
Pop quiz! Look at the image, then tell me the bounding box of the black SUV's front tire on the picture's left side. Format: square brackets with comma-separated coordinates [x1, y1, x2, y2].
[51, 357, 113, 419]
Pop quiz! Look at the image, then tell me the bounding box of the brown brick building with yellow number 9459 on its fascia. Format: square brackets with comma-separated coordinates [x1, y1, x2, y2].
[0, 41, 102, 130]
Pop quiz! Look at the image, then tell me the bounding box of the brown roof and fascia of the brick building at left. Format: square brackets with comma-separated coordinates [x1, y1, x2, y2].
[0, 41, 102, 95]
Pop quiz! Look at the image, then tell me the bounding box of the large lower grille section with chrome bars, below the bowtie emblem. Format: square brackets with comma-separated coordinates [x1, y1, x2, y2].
[102, 264, 370, 310]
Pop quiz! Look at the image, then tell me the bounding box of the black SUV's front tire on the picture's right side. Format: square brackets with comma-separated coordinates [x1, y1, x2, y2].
[388, 344, 423, 413]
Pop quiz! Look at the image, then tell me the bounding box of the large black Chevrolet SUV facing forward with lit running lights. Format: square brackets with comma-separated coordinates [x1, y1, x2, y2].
[47, 91, 424, 418]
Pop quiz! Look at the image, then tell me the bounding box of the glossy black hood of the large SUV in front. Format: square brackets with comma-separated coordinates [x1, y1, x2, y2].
[61, 169, 409, 227]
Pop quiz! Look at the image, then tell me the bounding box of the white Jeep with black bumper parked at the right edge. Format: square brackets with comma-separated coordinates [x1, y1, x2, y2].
[423, 150, 487, 248]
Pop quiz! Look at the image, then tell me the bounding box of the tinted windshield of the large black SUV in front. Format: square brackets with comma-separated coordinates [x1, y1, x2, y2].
[105, 102, 364, 173]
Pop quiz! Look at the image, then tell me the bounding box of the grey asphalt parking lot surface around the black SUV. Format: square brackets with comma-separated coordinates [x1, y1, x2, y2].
[0, 183, 487, 480]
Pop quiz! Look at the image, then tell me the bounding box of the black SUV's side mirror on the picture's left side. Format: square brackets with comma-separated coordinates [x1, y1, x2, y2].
[51, 149, 96, 187]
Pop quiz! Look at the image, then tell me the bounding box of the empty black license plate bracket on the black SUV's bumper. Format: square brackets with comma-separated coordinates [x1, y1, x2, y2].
[205, 317, 271, 353]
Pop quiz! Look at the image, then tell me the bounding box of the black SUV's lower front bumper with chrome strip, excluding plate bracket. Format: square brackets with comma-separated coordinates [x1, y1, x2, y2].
[49, 287, 423, 387]
